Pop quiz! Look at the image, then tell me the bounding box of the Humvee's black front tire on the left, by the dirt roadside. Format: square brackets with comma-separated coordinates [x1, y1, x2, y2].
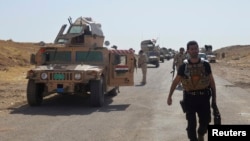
[27, 79, 44, 106]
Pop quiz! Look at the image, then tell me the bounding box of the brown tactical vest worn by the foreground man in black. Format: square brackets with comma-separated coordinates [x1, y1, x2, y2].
[181, 59, 210, 91]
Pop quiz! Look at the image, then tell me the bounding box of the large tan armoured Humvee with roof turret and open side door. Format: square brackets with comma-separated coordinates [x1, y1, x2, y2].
[26, 17, 134, 107]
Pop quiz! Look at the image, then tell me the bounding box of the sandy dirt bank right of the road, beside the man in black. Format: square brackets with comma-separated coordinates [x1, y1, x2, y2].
[211, 45, 250, 92]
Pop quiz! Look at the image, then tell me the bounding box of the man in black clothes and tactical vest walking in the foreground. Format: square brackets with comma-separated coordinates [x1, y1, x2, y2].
[167, 41, 216, 141]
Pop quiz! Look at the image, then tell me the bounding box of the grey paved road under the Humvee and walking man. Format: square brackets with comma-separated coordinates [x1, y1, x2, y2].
[0, 61, 250, 141]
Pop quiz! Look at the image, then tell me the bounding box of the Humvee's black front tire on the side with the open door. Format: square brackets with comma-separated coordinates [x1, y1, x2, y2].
[90, 79, 104, 107]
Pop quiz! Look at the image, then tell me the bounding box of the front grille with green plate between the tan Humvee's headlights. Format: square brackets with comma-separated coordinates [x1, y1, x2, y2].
[49, 72, 73, 81]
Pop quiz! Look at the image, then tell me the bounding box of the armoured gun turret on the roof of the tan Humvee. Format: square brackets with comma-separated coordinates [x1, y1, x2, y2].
[54, 17, 104, 47]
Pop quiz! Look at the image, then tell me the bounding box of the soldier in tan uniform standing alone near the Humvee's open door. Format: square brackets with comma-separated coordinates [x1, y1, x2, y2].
[138, 50, 147, 85]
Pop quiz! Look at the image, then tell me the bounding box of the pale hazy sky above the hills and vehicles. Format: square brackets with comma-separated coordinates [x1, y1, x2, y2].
[0, 0, 250, 52]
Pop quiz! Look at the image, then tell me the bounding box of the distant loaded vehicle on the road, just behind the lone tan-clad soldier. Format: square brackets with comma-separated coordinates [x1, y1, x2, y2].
[141, 40, 160, 68]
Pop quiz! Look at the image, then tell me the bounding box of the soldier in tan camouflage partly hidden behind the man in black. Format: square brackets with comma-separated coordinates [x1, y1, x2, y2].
[173, 47, 186, 87]
